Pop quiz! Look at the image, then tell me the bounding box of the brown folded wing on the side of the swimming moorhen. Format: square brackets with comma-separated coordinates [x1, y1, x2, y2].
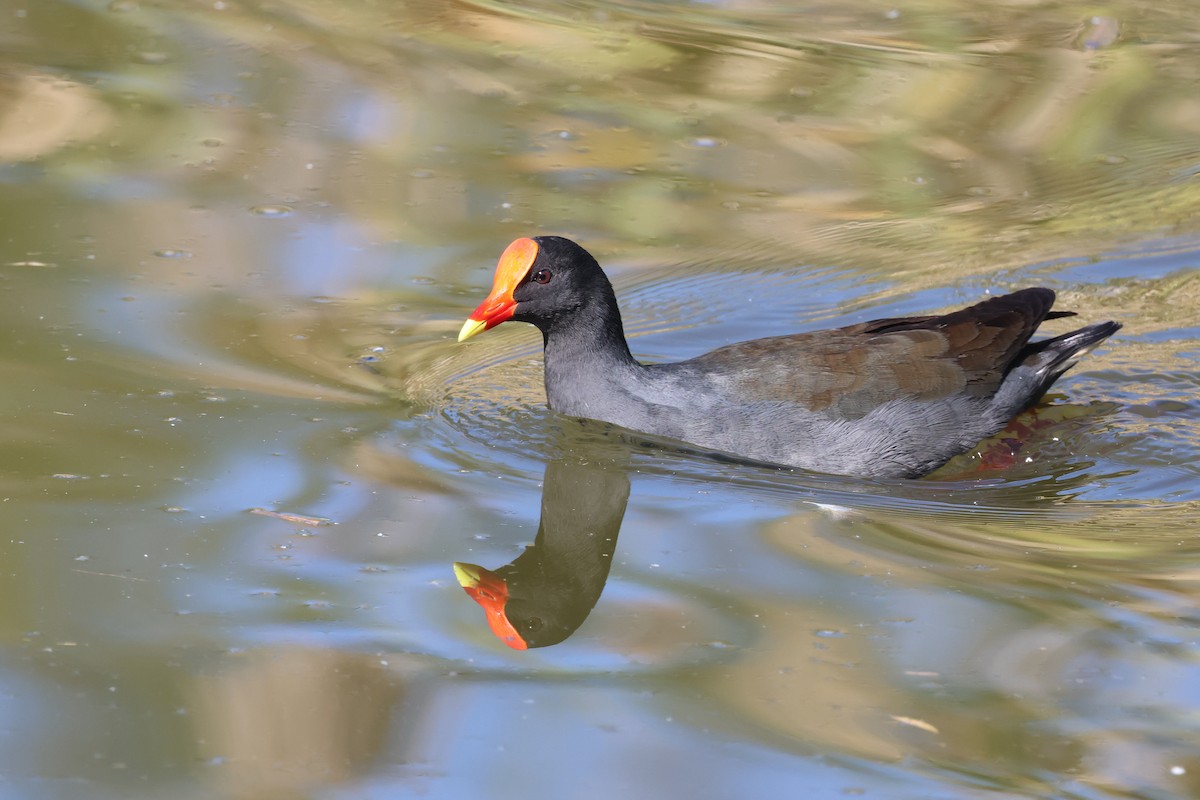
[690, 289, 1066, 419]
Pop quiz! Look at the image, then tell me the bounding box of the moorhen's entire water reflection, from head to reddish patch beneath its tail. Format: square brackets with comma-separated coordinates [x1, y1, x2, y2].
[454, 405, 1108, 650]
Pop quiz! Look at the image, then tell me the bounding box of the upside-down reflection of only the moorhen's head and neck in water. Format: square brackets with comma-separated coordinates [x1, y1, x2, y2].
[454, 458, 629, 650]
